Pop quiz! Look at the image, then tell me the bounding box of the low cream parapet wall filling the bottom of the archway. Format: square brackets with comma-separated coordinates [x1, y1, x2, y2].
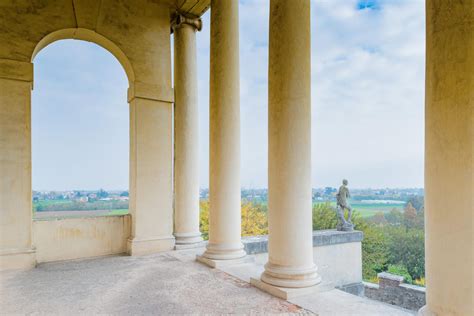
[33, 215, 131, 263]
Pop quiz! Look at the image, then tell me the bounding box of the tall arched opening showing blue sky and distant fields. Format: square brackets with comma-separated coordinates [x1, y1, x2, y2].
[31, 40, 129, 218]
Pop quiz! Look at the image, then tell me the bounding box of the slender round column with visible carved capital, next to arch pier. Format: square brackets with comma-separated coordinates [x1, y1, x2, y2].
[172, 15, 202, 244]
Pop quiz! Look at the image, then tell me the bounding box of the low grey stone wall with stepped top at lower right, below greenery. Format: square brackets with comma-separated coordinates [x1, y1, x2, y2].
[364, 272, 426, 311]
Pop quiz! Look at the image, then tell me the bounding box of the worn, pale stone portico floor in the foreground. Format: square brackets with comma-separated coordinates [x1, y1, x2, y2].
[0, 249, 410, 315]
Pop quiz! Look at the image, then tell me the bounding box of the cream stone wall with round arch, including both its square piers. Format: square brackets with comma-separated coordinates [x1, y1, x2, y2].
[0, 0, 175, 270]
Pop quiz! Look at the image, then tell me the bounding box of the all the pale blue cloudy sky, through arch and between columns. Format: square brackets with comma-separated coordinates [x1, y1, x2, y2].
[32, 0, 425, 190]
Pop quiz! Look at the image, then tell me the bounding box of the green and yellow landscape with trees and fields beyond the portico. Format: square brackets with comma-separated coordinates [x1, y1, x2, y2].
[33, 187, 425, 286]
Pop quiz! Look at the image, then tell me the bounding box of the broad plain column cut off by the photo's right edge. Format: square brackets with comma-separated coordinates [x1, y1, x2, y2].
[420, 0, 474, 315]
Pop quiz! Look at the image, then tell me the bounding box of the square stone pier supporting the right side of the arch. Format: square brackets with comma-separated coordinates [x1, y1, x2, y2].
[127, 82, 175, 255]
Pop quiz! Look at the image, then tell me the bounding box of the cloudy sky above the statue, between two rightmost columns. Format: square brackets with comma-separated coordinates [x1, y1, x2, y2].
[312, 1, 424, 187]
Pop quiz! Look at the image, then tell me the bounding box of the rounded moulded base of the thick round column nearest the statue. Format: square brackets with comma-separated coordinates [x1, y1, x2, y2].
[261, 262, 321, 288]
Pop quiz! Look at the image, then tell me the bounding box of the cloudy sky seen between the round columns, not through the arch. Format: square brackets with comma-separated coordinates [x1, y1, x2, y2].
[198, 0, 425, 187]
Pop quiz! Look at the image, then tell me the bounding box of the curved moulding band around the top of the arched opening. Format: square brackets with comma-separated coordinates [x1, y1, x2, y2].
[31, 28, 135, 86]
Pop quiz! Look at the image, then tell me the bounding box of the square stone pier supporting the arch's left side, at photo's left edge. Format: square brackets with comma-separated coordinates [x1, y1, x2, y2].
[0, 59, 36, 270]
